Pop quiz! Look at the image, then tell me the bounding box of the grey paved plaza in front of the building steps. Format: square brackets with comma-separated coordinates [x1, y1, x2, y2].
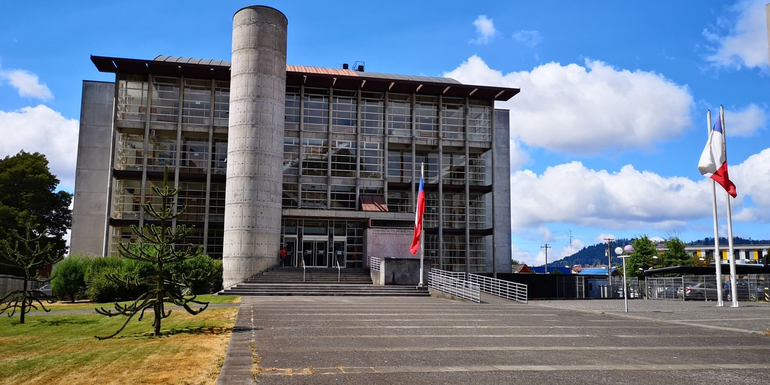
[214, 297, 770, 384]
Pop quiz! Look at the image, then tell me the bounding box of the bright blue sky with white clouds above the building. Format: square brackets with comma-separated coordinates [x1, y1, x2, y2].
[0, 0, 770, 264]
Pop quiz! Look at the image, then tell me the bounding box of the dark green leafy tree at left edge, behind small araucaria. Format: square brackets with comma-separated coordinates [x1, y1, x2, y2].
[0, 151, 72, 276]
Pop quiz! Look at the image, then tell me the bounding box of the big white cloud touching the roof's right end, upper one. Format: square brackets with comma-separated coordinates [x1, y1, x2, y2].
[444, 55, 693, 155]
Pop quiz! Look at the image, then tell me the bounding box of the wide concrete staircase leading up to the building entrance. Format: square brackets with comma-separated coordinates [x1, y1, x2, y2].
[217, 267, 430, 297]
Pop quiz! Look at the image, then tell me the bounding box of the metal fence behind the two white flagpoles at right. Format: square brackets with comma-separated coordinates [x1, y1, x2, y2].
[645, 274, 770, 302]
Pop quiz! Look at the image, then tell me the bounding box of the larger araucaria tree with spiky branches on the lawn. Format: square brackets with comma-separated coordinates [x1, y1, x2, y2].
[96, 167, 208, 339]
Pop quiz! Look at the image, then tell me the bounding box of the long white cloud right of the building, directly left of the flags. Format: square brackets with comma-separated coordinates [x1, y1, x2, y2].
[511, 162, 711, 229]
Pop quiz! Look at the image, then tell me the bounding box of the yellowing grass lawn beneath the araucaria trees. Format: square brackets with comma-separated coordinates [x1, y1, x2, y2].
[0, 297, 238, 384]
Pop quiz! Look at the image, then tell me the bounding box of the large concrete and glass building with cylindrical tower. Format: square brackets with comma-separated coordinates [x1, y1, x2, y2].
[71, 7, 519, 286]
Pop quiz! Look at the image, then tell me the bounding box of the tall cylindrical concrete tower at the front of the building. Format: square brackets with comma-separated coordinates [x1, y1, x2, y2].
[223, 6, 288, 287]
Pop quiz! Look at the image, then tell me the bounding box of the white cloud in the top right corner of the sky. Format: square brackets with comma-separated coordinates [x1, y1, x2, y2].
[703, 0, 768, 69]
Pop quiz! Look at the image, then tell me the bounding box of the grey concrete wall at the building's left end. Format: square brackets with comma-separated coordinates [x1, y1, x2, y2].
[70, 81, 115, 256]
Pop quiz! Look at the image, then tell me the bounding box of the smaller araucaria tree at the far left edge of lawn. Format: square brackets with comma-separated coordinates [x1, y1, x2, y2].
[0, 223, 62, 323]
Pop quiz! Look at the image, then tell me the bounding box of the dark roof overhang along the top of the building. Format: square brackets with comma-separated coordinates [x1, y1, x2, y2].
[91, 55, 520, 101]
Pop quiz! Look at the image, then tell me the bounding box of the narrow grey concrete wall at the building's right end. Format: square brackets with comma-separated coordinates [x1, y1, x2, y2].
[487, 110, 512, 273]
